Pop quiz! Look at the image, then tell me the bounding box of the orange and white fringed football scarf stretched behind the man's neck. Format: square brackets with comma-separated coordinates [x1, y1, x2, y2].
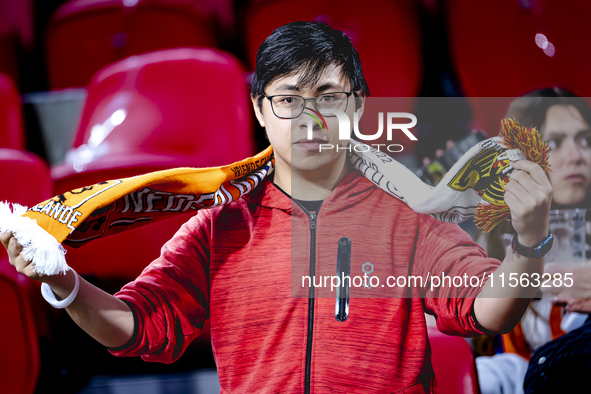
[0, 119, 549, 275]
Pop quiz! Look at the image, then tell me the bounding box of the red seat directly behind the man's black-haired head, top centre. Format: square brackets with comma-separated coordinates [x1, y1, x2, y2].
[246, 0, 422, 153]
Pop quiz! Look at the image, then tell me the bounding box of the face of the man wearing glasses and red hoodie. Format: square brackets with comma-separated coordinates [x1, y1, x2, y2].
[253, 65, 361, 171]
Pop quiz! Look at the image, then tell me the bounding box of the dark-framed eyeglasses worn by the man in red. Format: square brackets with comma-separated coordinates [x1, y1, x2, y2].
[263, 92, 353, 119]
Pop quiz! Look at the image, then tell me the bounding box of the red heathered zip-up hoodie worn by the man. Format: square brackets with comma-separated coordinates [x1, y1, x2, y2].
[110, 171, 500, 393]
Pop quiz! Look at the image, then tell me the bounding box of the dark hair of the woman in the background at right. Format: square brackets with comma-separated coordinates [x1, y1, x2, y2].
[505, 87, 591, 131]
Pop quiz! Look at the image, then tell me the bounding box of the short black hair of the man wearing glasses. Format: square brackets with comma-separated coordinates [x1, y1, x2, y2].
[250, 22, 369, 108]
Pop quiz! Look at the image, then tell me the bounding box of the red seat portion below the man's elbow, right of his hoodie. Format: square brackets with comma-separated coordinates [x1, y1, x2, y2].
[428, 327, 479, 394]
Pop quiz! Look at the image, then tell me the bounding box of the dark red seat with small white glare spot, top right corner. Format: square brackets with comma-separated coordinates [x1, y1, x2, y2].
[447, 0, 591, 135]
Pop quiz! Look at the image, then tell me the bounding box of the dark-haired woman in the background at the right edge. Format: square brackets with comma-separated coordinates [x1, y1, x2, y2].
[475, 88, 591, 394]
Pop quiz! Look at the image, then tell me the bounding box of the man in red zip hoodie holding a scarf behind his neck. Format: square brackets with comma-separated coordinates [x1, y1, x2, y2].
[2, 22, 551, 393]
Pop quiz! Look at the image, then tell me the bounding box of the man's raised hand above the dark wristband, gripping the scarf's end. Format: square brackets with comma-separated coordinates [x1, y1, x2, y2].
[505, 160, 552, 247]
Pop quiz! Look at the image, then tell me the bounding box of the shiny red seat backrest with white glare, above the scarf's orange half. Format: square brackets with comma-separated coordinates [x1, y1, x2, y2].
[52, 48, 254, 193]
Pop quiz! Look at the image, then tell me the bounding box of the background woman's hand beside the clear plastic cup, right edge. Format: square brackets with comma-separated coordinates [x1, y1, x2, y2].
[540, 264, 591, 313]
